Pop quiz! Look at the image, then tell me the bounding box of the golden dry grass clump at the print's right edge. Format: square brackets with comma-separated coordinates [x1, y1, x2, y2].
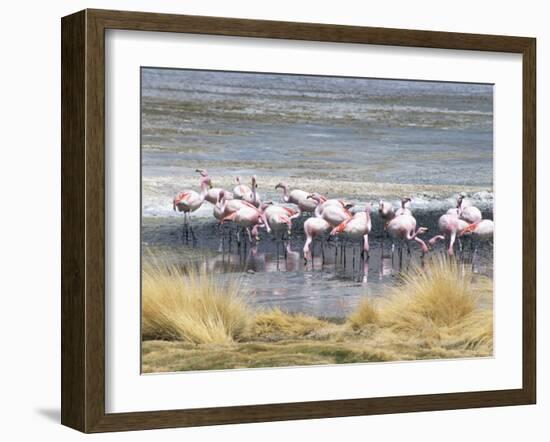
[348, 256, 493, 353]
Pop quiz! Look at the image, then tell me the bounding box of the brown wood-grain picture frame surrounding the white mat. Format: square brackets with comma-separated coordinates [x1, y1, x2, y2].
[61, 10, 536, 432]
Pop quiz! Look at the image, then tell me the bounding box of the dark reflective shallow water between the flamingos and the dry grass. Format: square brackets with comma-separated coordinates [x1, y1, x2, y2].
[142, 212, 492, 318]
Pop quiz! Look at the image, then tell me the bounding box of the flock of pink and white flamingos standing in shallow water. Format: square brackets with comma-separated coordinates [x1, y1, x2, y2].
[173, 169, 494, 262]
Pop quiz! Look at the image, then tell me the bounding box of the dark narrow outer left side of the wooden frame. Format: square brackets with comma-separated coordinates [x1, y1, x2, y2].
[61, 12, 87, 429]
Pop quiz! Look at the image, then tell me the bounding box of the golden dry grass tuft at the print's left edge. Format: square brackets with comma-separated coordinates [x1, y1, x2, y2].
[142, 261, 253, 344]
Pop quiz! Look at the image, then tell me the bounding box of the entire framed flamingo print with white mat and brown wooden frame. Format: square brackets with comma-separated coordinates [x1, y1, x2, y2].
[62, 10, 536, 432]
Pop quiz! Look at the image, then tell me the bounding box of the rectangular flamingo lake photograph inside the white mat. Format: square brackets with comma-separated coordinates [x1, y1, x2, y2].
[141, 66, 496, 374]
